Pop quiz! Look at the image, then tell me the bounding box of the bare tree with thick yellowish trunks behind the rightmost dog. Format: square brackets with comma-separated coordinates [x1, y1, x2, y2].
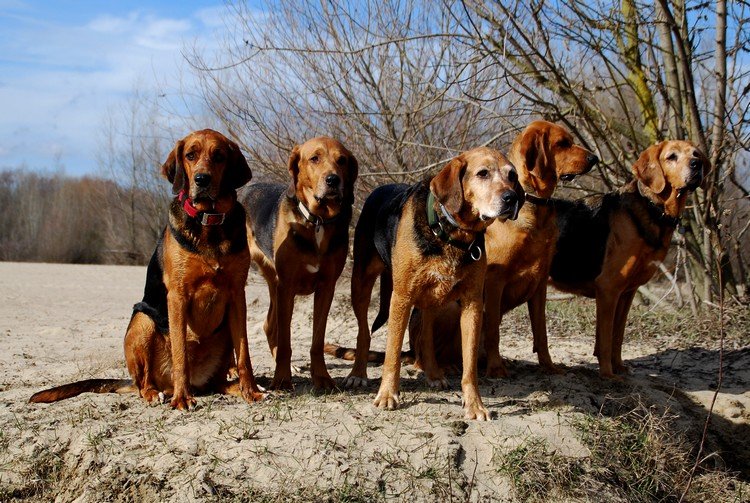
[460, 0, 750, 308]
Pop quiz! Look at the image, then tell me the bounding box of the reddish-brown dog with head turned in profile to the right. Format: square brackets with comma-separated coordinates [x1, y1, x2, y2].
[409, 121, 598, 377]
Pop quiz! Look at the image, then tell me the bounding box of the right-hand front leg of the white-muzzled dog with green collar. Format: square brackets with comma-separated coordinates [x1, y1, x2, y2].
[461, 296, 490, 421]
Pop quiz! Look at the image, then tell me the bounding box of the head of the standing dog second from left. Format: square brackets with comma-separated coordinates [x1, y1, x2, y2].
[289, 136, 359, 219]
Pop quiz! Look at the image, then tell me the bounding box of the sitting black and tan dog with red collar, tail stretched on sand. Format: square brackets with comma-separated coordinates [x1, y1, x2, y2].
[30, 129, 263, 409]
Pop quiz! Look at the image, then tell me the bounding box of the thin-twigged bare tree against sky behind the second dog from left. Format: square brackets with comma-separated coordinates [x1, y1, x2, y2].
[191, 0, 524, 201]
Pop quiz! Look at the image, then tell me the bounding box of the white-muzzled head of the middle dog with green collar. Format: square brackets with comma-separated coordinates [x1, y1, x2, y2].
[430, 147, 524, 230]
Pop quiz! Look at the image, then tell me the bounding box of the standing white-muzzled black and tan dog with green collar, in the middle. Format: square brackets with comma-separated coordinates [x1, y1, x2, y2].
[338, 148, 523, 420]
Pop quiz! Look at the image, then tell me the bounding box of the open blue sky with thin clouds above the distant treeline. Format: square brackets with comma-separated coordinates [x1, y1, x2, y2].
[0, 0, 241, 175]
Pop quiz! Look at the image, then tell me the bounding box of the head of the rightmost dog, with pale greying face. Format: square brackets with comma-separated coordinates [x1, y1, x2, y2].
[633, 140, 711, 214]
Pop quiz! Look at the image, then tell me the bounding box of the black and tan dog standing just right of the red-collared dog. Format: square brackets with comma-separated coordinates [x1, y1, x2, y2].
[240, 137, 358, 389]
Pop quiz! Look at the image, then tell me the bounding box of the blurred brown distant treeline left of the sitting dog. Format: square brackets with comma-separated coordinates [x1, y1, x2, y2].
[0, 169, 167, 264]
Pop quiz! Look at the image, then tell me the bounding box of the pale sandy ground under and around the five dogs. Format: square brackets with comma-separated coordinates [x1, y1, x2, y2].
[0, 263, 750, 502]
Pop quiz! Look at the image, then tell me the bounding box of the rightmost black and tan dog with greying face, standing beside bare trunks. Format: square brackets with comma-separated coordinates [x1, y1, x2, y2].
[539, 141, 709, 378]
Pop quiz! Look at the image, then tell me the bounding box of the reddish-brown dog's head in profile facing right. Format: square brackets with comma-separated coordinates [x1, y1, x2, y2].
[511, 121, 599, 197]
